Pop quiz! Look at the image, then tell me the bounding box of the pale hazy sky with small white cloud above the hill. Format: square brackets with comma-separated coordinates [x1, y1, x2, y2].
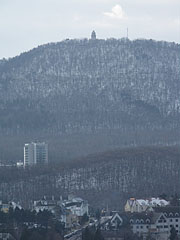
[0, 0, 180, 58]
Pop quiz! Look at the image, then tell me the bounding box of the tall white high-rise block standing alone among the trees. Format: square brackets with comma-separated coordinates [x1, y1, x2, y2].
[24, 142, 48, 167]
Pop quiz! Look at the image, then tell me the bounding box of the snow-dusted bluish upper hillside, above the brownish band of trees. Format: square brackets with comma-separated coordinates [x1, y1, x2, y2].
[0, 39, 180, 133]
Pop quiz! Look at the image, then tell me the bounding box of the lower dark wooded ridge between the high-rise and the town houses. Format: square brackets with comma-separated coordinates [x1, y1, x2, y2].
[0, 147, 180, 210]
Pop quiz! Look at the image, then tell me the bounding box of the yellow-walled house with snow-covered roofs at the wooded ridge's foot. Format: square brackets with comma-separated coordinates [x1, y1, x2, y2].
[124, 198, 169, 213]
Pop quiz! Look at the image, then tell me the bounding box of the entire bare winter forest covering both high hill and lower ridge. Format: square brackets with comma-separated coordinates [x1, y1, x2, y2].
[0, 39, 180, 209]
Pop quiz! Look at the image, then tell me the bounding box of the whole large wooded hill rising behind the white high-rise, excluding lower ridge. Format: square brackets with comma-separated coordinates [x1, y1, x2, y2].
[0, 38, 180, 162]
